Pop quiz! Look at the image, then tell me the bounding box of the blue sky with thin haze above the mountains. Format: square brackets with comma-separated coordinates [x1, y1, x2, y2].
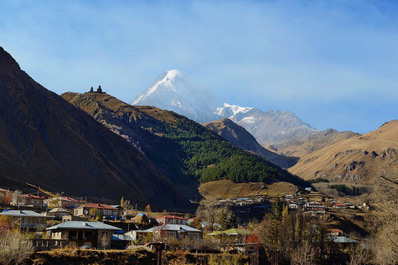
[0, 0, 398, 132]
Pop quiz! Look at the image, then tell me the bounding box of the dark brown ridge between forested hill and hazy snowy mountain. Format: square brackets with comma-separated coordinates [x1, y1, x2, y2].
[202, 119, 298, 168]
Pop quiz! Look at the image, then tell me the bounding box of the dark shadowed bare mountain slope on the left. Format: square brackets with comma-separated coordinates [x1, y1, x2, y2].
[0, 48, 189, 209]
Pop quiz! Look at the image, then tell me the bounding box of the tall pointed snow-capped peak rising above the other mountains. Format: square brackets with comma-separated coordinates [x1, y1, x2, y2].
[131, 70, 221, 122]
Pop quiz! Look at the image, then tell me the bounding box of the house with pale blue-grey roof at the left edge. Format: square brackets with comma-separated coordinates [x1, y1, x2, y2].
[0, 210, 51, 230]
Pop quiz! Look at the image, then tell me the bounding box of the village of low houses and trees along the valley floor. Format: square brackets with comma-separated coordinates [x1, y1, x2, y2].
[0, 184, 369, 264]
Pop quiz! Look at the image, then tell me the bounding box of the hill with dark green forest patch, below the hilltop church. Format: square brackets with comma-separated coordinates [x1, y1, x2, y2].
[62, 93, 303, 193]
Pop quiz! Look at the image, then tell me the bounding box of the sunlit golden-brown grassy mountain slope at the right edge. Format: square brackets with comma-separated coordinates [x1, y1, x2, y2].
[289, 120, 398, 184]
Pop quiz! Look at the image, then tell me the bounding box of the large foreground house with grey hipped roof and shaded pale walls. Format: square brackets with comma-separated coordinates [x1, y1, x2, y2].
[47, 221, 120, 249]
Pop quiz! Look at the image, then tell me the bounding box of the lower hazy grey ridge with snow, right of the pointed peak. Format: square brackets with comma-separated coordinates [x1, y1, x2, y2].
[216, 103, 316, 144]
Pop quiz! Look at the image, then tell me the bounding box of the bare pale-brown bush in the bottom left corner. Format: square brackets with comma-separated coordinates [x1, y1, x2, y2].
[0, 229, 34, 265]
